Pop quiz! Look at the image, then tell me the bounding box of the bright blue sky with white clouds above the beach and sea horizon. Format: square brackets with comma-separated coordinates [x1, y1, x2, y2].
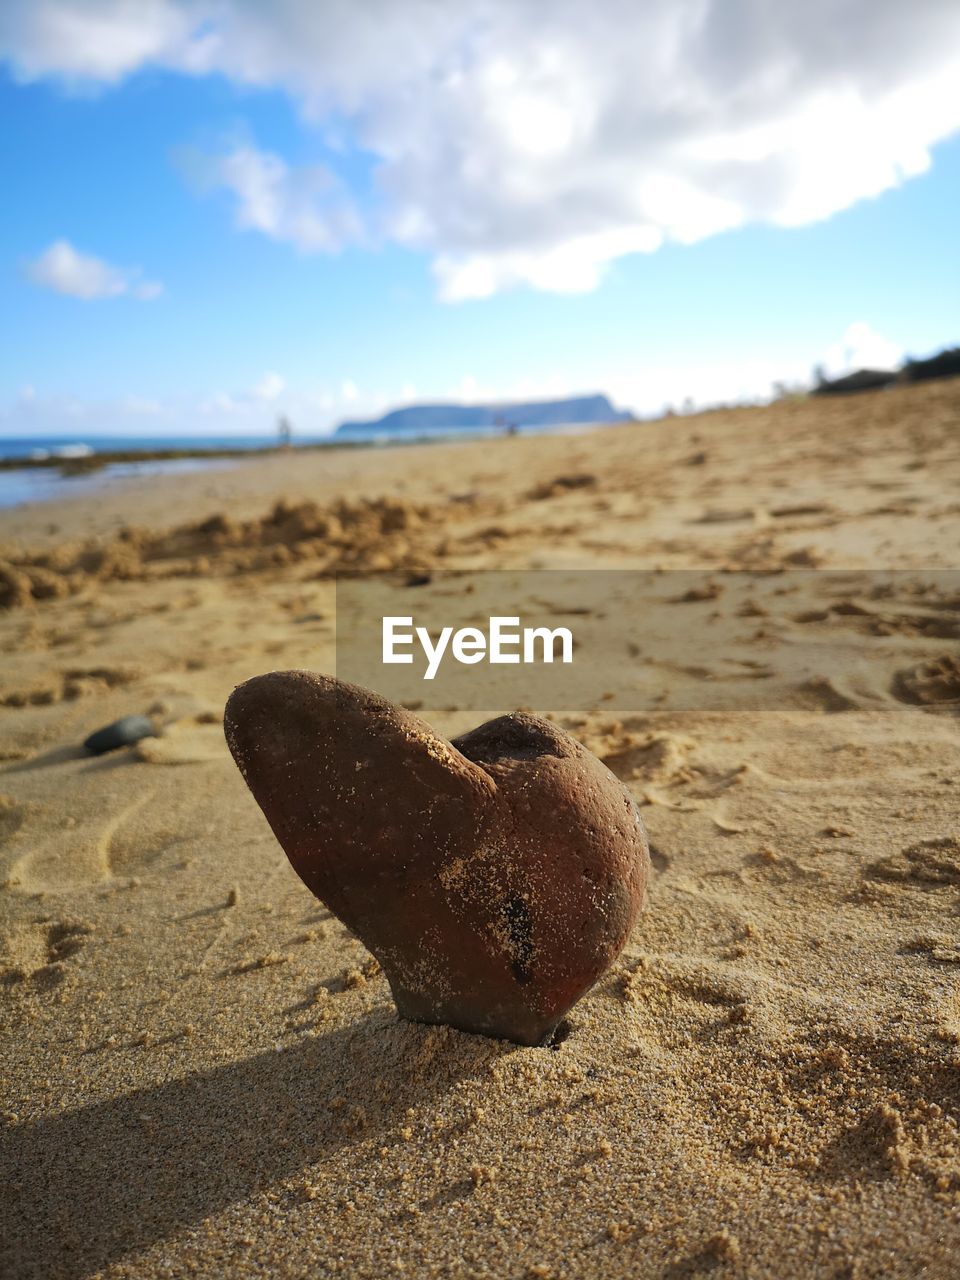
[0, 0, 960, 436]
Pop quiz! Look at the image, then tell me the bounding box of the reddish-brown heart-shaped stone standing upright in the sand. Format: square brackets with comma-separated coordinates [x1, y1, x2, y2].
[224, 671, 649, 1044]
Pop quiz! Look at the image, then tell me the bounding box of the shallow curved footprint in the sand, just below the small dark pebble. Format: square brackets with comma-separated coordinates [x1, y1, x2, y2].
[5, 790, 161, 893]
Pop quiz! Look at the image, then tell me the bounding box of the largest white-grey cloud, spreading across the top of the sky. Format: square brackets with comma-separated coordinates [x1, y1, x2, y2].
[0, 0, 960, 301]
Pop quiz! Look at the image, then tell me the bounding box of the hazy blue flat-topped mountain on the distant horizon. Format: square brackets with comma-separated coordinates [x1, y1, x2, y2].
[335, 396, 632, 435]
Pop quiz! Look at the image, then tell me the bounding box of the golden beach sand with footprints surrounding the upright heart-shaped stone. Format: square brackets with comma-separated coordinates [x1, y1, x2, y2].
[0, 381, 960, 1280]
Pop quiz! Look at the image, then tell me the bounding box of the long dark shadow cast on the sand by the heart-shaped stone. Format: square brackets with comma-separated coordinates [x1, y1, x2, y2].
[0, 1010, 515, 1280]
